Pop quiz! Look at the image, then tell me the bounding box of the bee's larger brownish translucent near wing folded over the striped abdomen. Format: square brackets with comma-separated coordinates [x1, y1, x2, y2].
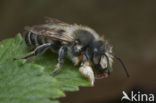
[25, 25, 74, 43]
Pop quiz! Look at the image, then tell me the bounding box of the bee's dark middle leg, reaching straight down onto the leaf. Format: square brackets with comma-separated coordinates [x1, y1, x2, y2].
[51, 47, 67, 76]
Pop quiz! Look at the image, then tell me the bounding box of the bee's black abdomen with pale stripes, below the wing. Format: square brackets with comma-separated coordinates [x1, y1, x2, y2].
[24, 32, 61, 50]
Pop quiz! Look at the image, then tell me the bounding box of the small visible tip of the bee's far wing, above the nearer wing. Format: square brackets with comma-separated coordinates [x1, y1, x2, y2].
[45, 17, 69, 25]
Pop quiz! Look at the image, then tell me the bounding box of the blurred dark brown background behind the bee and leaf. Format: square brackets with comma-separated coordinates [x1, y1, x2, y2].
[0, 0, 156, 103]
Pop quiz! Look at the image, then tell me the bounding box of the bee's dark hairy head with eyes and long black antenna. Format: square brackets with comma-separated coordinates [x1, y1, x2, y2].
[90, 41, 129, 76]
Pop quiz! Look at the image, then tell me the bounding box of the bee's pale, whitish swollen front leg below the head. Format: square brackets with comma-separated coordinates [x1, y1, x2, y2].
[79, 55, 95, 86]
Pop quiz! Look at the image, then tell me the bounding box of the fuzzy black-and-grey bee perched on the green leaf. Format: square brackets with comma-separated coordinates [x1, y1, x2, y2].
[15, 18, 129, 86]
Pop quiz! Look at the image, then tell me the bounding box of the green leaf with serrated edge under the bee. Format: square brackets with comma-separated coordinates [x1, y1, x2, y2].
[0, 34, 90, 103]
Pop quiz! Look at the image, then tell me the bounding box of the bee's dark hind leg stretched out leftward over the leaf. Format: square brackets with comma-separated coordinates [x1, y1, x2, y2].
[14, 43, 53, 60]
